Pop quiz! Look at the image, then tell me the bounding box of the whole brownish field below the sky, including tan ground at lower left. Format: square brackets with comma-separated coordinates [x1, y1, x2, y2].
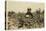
[5, 11, 44, 30]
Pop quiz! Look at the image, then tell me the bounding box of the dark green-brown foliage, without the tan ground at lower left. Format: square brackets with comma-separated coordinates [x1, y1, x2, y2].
[8, 11, 44, 28]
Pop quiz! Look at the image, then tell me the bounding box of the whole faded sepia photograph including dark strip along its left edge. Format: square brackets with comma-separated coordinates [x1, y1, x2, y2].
[5, 1, 44, 30]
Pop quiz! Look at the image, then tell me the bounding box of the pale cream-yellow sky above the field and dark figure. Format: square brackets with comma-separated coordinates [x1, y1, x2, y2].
[7, 1, 44, 13]
